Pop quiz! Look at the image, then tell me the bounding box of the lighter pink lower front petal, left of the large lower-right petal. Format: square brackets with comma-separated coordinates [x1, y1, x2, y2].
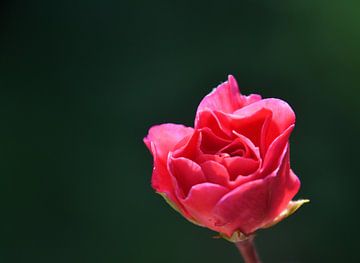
[181, 183, 229, 231]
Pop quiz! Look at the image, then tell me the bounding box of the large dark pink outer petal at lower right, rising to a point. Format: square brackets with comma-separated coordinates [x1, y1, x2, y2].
[214, 147, 300, 236]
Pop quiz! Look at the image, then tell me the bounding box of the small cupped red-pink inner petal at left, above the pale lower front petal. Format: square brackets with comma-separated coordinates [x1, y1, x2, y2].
[169, 157, 206, 198]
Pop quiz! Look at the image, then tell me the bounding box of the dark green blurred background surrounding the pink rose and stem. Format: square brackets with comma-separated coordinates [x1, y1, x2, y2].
[0, 0, 360, 263]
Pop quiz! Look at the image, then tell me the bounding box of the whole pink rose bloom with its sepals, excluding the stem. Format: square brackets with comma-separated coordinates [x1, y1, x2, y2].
[144, 76, 306, 240]
